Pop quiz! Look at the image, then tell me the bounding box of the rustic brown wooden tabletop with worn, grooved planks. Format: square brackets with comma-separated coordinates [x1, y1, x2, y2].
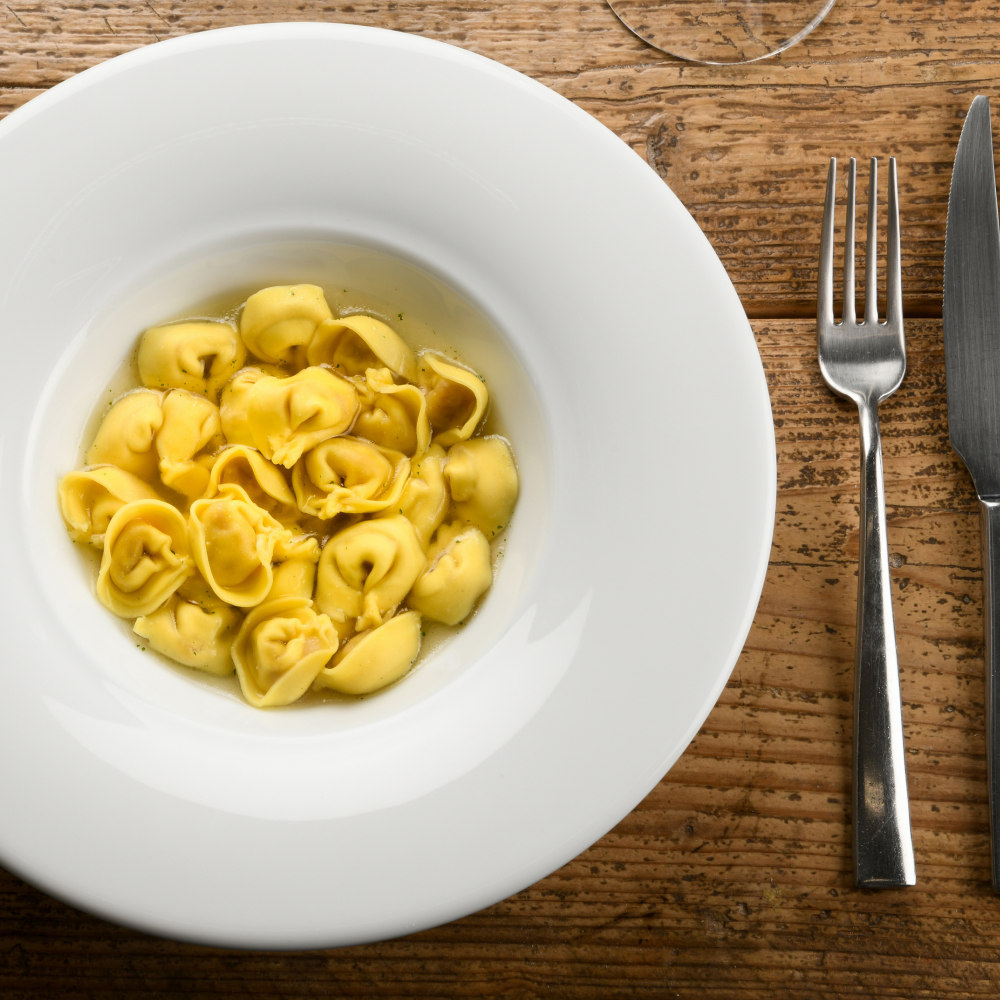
[0, 0, 1000, 1000]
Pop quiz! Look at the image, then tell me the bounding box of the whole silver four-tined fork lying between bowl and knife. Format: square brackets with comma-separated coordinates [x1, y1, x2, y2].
[816, 157, 916, 888]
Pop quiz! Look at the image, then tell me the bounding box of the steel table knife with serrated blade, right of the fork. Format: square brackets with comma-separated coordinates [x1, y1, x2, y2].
[943, 96, 1000, 891]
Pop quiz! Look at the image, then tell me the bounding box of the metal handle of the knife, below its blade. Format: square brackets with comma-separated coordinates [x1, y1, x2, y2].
[979, 499, 1000, 892]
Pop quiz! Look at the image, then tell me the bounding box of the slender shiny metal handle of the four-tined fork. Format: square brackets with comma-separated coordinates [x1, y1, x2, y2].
[853, 403, 917, 888]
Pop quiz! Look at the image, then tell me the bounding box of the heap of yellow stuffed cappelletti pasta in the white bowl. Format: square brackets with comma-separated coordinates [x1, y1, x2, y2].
[59, 284, 519, 708]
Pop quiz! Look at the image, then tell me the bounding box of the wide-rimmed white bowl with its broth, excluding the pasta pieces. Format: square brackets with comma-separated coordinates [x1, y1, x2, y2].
[0, 24, 775, 947]
